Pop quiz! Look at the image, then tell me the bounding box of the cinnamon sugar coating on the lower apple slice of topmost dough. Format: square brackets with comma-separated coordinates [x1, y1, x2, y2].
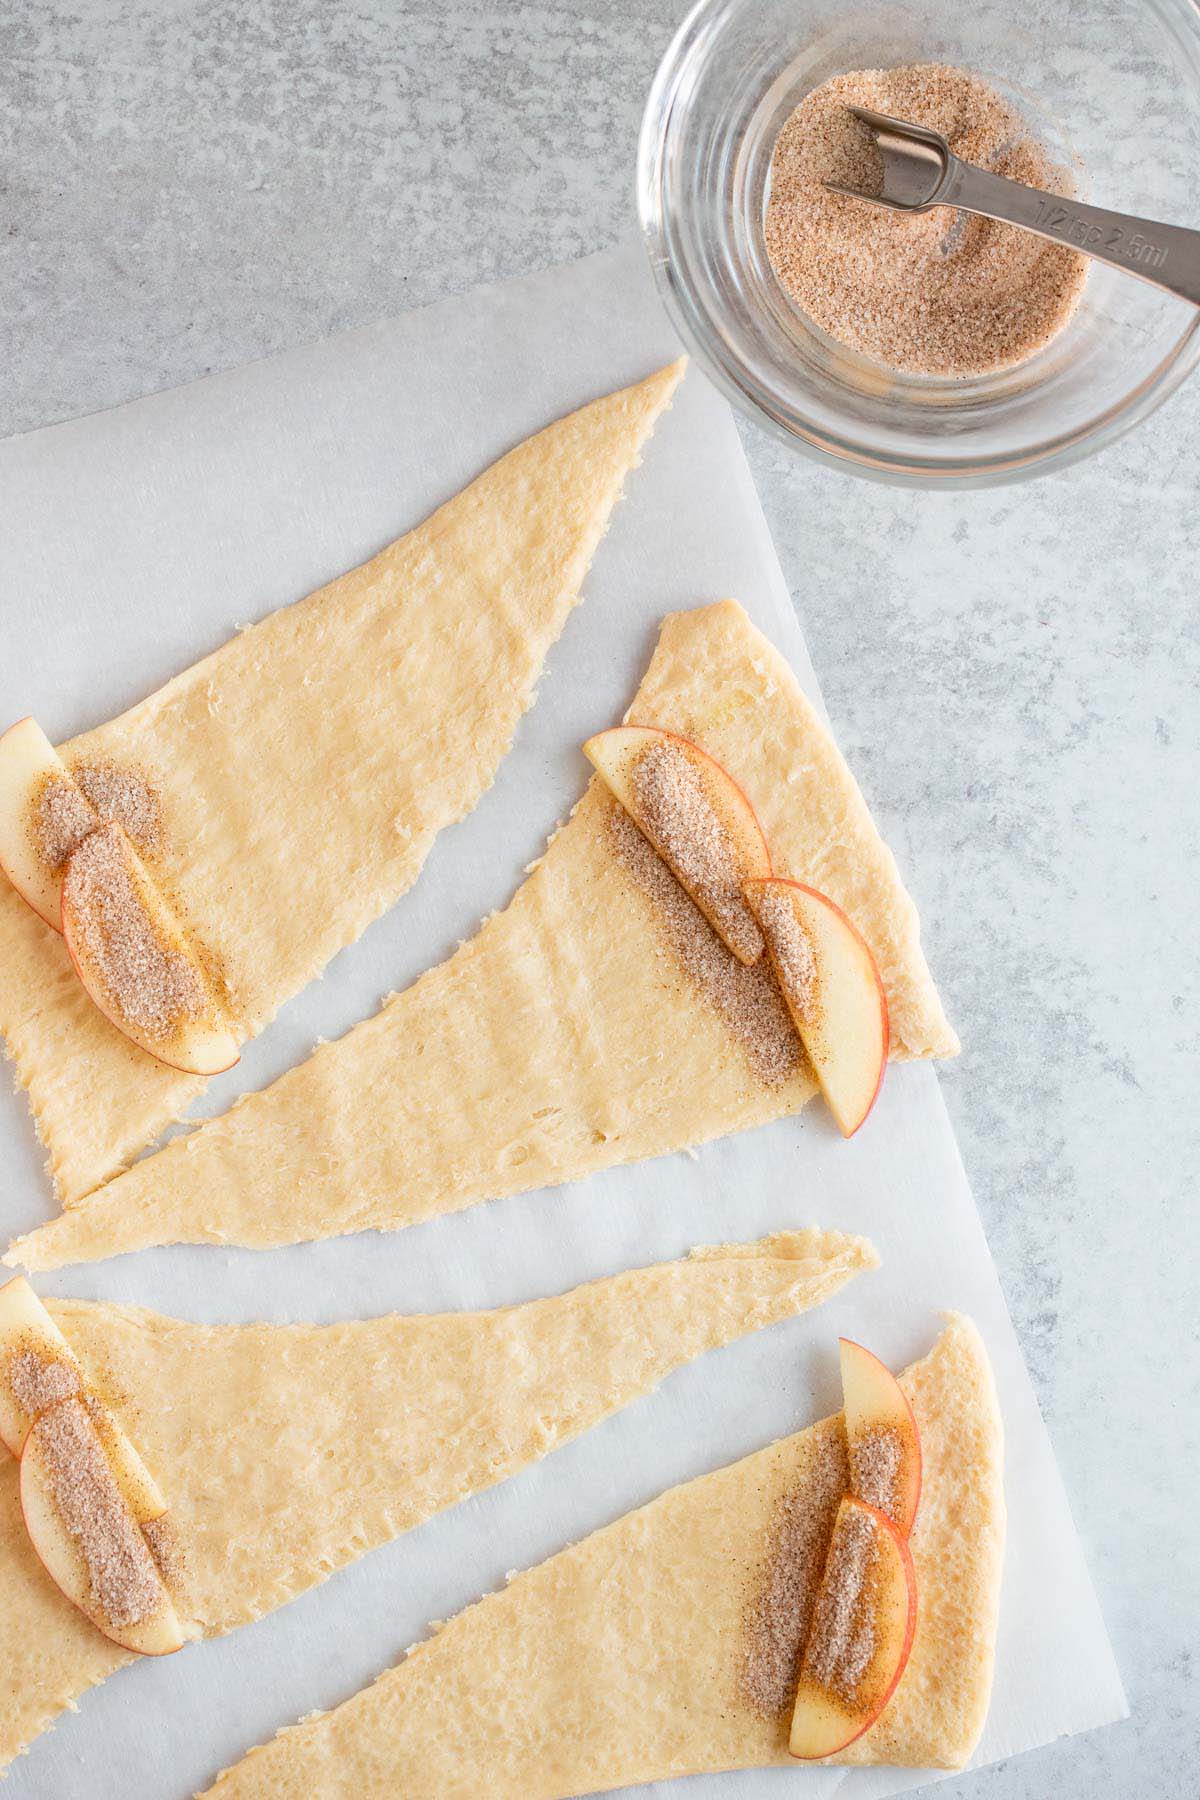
[68, 824, 207, 1039]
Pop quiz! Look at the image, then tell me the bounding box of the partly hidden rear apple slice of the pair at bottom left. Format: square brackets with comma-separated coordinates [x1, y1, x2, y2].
[0, 1274, 167, 1525]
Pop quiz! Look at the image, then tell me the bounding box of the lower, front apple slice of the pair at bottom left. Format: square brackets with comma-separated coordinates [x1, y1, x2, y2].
[20, 1397, 187, 1656]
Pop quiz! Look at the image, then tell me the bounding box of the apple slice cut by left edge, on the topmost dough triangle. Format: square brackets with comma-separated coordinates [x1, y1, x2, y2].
[0, 718, 99, 931]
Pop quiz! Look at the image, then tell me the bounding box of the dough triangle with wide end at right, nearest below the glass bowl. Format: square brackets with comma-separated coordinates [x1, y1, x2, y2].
[5, 601, 957, 1269]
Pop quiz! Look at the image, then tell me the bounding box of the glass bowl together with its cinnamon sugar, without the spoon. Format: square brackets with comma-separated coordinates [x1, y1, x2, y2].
[639, 0, 1200, 488]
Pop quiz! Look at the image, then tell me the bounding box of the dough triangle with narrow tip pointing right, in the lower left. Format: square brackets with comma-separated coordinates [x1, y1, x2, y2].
[0, 1231, 878, 1769]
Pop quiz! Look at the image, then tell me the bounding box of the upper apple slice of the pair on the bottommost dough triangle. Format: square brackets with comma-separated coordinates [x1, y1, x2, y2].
[838, 1337, 921, 1537]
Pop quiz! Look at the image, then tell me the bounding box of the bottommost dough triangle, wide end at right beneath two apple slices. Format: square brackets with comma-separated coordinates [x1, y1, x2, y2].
[210, 1318, 1004, 1800]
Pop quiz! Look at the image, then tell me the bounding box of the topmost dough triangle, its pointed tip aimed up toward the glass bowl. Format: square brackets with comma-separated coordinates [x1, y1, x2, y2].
[0, 362, 684, 1204]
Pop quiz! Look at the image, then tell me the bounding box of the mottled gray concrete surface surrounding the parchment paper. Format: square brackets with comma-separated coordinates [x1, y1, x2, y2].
[0, 0, 1200, 1800]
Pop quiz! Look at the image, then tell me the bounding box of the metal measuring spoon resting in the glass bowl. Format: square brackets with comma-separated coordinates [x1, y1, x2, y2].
[826, 106, 1200, 306]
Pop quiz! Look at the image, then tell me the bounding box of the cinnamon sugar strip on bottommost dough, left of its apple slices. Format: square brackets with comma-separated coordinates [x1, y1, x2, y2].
[741, 1433, 846, 1719]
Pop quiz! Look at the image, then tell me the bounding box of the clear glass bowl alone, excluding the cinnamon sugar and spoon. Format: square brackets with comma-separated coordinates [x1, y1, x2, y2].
[637, 0, 1200, 488]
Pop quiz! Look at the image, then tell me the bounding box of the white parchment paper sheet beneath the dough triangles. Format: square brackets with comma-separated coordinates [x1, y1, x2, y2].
[0, 247, 1124, 1800]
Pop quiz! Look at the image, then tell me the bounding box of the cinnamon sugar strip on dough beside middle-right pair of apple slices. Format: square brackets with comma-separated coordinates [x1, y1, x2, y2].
[608, 801, 804, 1087]
